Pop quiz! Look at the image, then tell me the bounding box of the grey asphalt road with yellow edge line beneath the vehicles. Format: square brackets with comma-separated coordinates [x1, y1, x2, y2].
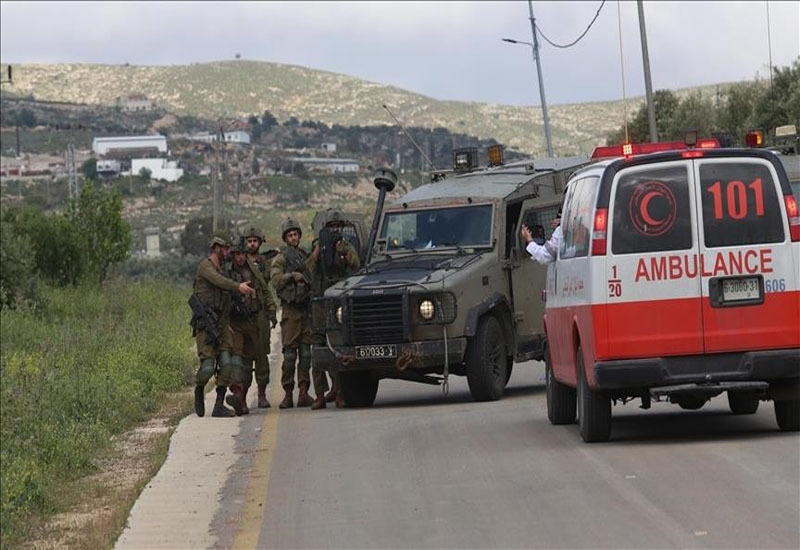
[115, 362, 800, 548]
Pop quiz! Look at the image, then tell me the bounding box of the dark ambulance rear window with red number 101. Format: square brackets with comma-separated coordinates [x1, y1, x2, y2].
[700, 162, 784, 247]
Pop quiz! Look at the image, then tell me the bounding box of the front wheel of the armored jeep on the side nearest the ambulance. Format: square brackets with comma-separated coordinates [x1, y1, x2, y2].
[466, 315, 508, 401]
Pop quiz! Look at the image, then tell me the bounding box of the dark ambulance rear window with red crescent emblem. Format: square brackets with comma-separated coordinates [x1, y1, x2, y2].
[611, 164, 692, 254]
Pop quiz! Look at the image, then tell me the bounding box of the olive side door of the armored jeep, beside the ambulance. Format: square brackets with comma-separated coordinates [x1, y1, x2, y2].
[511, 199, 560, 348]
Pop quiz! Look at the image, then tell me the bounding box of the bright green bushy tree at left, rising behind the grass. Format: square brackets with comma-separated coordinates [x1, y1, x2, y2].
[67, 182, 131, 282]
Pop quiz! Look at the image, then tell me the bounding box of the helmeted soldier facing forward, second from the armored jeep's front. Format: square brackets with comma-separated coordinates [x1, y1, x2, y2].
[270, 218, 316, 409]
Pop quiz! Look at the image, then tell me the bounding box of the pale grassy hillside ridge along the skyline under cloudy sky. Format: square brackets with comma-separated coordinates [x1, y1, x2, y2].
[3, 60, 700, 156]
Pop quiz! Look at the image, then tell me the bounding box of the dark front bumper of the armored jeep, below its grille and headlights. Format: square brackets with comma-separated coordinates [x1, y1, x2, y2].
[312, 338, 467, 372]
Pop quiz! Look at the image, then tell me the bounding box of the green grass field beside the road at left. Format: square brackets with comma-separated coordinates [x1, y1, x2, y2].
[0, 280, 194, 547]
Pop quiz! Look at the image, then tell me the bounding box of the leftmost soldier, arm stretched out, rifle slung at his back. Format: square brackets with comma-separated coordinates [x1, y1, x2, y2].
[190, 233, 255, 417]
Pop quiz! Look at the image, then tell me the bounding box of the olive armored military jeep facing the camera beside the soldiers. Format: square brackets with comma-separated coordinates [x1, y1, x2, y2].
[313, 149, 589, 407]
